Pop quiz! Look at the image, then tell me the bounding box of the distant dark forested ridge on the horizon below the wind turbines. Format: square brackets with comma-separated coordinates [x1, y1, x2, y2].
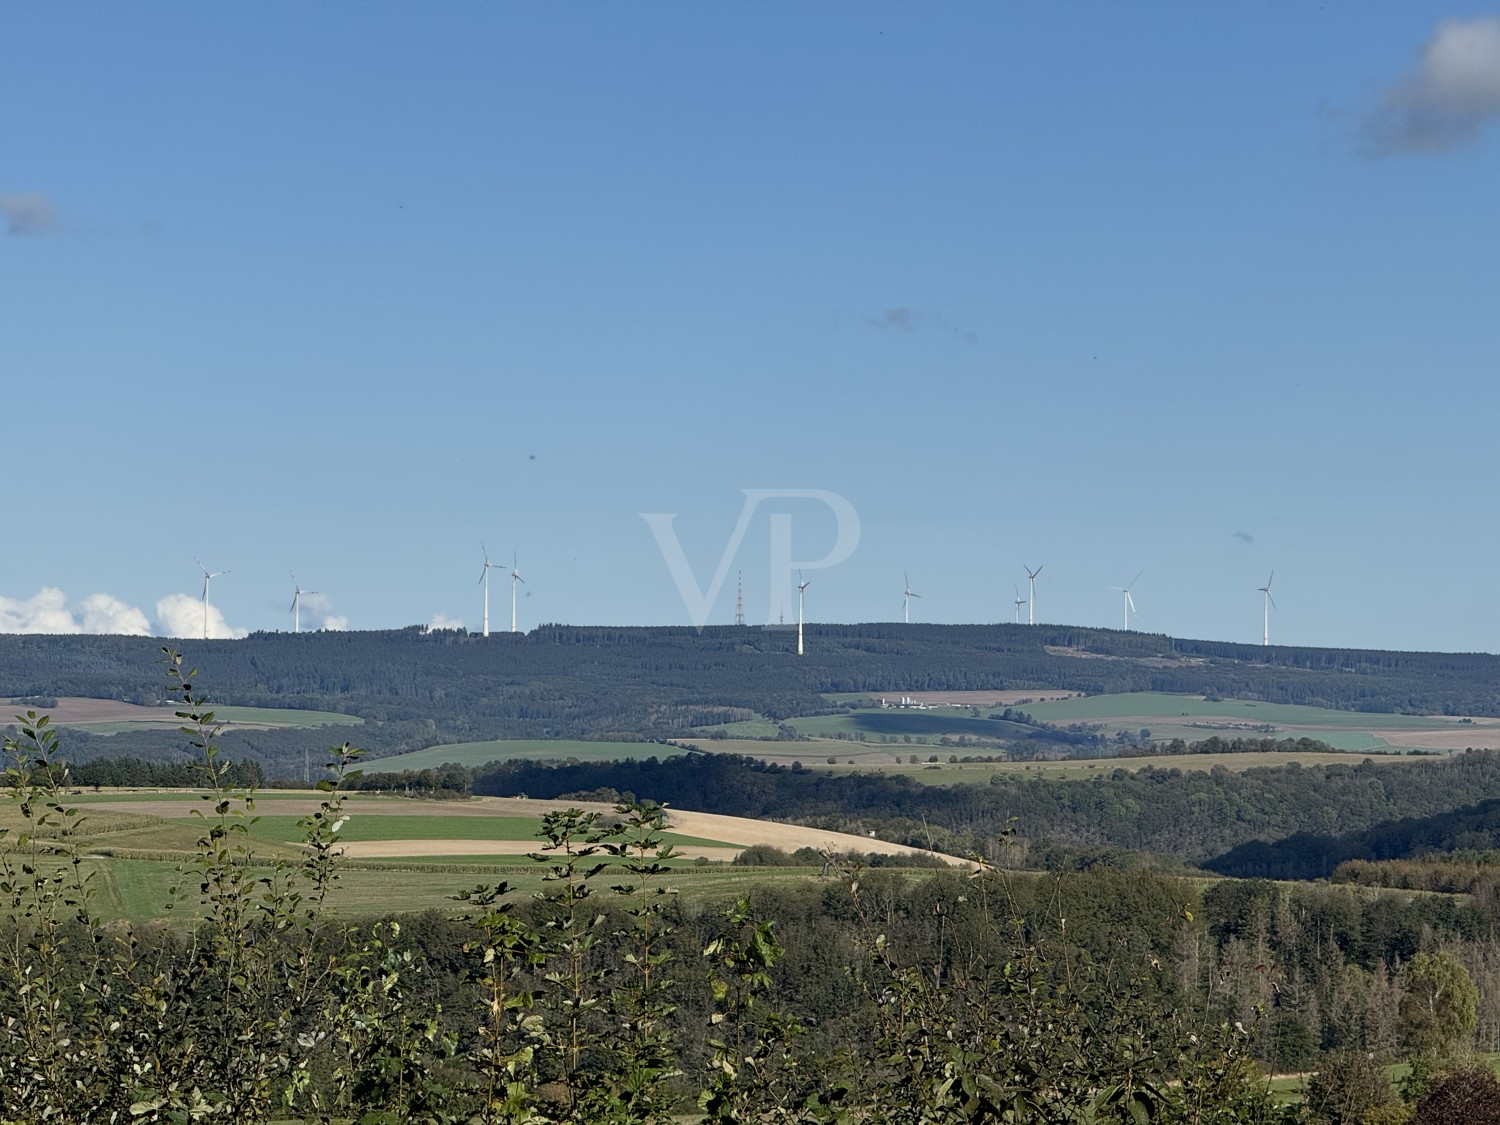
[0, 624, 1500, 777]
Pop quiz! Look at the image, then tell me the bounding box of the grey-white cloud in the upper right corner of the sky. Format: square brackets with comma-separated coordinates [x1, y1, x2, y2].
[1362, 17, 1500, 156]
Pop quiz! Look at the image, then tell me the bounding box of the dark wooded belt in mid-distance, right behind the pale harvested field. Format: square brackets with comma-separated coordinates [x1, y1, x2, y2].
[473, 750, 1500, 878]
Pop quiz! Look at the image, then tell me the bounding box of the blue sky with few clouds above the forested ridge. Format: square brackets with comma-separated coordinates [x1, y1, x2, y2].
[0, 0, 1500, 651]
